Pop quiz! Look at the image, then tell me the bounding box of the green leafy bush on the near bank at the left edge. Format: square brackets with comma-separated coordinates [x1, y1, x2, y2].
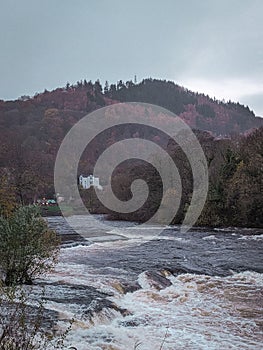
[0, 206, 59, 285]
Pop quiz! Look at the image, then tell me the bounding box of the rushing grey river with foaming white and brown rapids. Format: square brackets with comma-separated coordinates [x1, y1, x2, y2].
[37, 216, 263, 350]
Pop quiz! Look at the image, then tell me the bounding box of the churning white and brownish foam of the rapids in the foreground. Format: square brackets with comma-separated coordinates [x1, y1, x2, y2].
[39, 260, 263, 350]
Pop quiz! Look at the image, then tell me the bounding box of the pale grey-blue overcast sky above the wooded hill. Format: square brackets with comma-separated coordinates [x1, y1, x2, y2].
[0, 0, 263, 116]
